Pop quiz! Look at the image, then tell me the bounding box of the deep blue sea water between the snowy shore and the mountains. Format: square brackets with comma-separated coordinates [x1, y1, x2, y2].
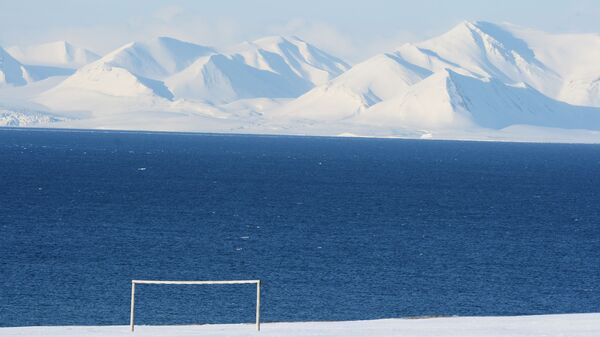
[0, 130, 600, 326]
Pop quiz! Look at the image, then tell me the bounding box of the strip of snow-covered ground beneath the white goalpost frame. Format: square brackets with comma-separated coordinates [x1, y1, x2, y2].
[0, 314, 600, 337]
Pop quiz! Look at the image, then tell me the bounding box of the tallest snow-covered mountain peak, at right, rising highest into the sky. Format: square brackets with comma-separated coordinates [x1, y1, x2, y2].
[395, 22, 560, 94]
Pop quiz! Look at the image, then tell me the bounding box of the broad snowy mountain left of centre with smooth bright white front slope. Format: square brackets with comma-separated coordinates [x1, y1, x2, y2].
[37, 37, 214, 111]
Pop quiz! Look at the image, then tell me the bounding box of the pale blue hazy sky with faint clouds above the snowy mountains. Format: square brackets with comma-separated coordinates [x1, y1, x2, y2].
[0, 0, 600, 62]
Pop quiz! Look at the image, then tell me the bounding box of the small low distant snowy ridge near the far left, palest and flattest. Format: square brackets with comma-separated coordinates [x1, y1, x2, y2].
[6, 41, 100, 69]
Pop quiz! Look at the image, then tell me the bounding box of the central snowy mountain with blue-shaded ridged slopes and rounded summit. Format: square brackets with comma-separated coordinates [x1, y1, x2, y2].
[166, 37, 349, 104]
